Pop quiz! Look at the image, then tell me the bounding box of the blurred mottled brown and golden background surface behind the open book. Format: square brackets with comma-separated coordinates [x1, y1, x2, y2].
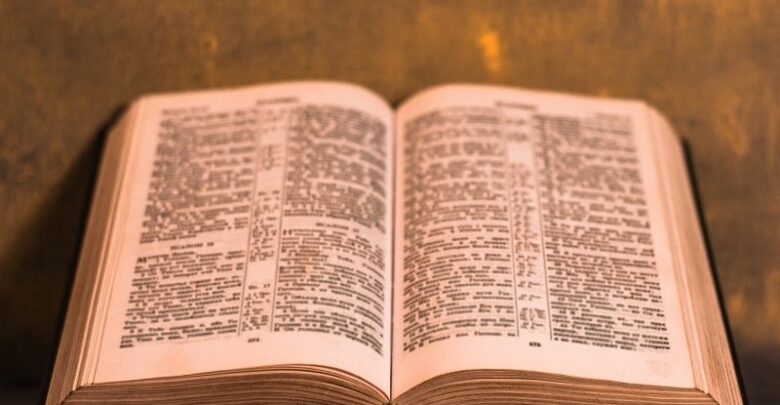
[0, 0, 780, 405]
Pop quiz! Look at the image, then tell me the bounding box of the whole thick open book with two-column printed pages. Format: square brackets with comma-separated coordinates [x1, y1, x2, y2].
[47, 82, 742, 405]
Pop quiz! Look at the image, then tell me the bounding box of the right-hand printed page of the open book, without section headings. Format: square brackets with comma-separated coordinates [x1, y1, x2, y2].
[392, 85, 694, 397]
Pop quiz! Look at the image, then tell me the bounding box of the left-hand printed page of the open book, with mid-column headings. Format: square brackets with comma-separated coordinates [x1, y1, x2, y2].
[90, 82, 393, 393]
